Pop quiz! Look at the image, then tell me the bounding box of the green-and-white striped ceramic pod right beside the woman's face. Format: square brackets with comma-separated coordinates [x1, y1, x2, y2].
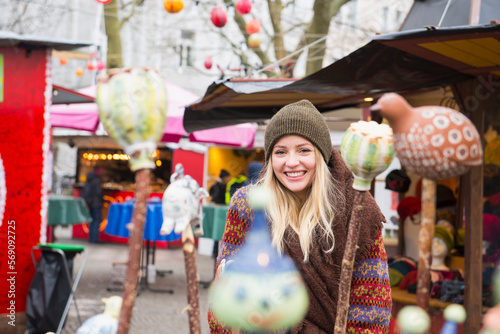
[340, 121, 394, 191]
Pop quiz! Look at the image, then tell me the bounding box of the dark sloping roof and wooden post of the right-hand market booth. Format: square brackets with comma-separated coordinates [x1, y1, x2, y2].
[184, 21, 500, 333]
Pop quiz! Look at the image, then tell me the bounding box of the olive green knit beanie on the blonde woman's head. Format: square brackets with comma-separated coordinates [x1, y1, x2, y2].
[264, 100, 332, 163]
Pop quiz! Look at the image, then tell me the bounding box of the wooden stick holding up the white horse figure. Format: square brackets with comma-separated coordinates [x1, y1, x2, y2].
[182, 224, 201, 334]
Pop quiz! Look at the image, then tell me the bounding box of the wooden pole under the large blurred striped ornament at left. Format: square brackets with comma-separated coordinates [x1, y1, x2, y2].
[117, 169, 150, 334]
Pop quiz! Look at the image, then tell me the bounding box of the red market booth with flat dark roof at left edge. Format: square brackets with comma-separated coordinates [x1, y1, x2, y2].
[0, 31, 91, 333]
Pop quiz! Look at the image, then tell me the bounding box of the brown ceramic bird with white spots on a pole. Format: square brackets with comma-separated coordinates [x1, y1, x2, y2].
[372, 93, 483, 179]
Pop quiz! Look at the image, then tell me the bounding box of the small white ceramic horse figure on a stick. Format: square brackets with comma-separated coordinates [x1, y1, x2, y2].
[160, 164, 208, 236]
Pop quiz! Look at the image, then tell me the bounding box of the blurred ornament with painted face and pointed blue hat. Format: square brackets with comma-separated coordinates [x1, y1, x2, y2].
[212, 186, 309, 332]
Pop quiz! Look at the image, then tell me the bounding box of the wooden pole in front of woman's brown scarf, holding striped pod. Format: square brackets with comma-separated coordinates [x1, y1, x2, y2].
[333, 190, 366, 334]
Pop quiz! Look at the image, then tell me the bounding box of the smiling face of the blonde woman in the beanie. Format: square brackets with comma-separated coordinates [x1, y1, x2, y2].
[271, 135, 316, 201]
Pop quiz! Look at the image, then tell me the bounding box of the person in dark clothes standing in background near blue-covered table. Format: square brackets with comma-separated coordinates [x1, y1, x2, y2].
[80, 166, 104, 243]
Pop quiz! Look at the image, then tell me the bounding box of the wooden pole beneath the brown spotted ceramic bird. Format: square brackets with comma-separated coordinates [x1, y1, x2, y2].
[417, 178, 436, 311]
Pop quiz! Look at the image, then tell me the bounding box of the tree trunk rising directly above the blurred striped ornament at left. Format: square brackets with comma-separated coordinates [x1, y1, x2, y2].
[104, 1, 123, 68]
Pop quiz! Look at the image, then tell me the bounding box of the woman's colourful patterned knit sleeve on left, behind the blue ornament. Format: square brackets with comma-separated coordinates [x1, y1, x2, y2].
[208, 187, 251, 334]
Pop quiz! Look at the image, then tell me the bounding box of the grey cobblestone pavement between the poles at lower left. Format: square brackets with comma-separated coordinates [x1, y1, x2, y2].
[57, 235, 214, 334]
